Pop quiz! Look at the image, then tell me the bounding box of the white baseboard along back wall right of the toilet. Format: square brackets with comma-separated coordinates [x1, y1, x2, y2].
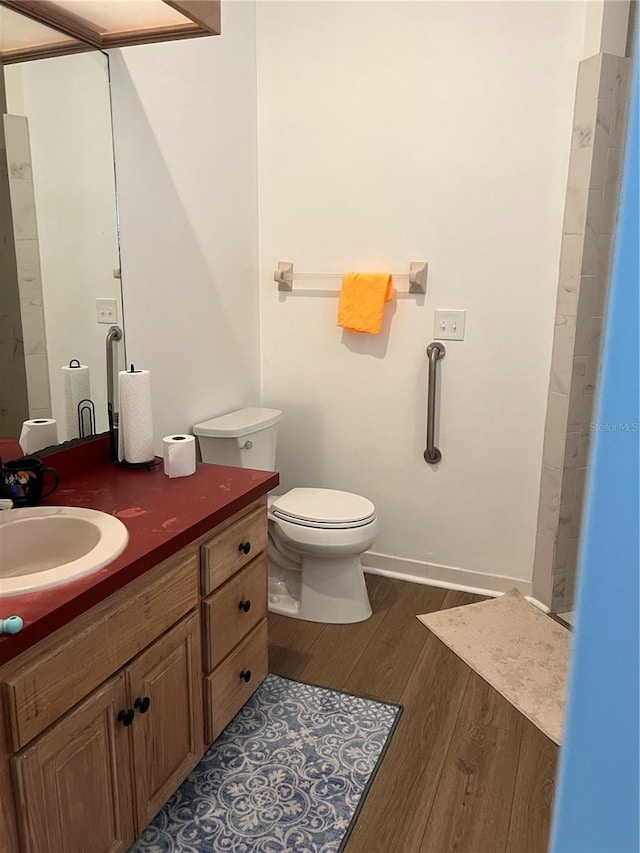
[362, 551, 532, 596]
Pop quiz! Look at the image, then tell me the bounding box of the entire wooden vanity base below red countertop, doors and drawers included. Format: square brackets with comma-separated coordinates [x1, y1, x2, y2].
[0, 498, 268, 853]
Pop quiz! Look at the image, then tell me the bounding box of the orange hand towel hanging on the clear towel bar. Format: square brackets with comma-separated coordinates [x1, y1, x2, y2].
[337, 272, 393, 335]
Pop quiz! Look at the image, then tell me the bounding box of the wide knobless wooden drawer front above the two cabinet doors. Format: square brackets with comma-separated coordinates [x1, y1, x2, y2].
[1, 553, 198, 750]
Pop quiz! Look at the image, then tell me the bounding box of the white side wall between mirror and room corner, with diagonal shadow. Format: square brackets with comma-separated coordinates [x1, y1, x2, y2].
[111, 3, 259, 453]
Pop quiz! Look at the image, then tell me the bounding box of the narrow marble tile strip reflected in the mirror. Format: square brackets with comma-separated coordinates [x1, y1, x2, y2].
[4, 115, 51, 418]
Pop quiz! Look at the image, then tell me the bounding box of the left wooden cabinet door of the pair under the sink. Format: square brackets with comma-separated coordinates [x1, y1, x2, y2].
[12, 675, 135, 853]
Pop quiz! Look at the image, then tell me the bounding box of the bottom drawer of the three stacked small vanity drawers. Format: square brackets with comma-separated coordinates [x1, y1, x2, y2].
[204, 619, 269, 744]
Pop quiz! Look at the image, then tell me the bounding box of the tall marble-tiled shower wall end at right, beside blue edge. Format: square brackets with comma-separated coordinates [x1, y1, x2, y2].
[533, 53, 631, 612]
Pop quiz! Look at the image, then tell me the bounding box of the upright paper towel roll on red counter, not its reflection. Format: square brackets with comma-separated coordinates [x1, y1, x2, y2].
[118, 365, 154, 464]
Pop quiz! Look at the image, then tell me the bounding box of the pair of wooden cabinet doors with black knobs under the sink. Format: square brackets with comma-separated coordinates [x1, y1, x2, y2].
[12, 613, 203, 853]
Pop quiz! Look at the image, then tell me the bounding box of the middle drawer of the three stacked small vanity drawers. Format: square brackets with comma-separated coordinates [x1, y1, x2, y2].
[202, 553, 267, 672]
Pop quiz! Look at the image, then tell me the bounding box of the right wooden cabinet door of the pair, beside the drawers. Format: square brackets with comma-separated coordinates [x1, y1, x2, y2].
[126, 613, 204, 832]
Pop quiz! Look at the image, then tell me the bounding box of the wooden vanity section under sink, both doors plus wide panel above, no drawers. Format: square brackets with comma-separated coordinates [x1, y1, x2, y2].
[0, 544, 204, 853]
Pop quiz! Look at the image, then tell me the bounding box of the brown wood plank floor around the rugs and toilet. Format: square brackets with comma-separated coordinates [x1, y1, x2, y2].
[269, 575, 558, 853]
